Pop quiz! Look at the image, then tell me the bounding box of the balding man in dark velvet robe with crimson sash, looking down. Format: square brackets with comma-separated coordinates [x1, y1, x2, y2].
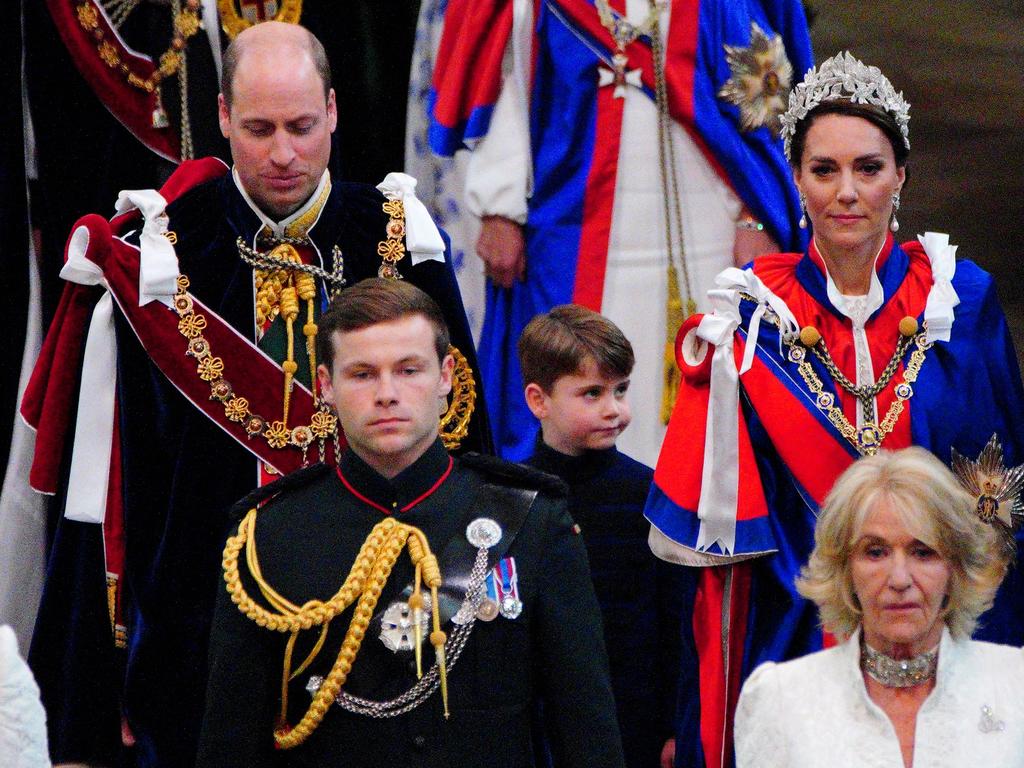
[25, 24, 489, 766]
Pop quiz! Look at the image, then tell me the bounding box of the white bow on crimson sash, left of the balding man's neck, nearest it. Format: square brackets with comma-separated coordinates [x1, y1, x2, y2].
[114, 189, 178, 306]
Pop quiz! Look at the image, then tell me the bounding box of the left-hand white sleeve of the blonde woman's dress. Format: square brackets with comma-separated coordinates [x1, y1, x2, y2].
[733, 662, 790, 768]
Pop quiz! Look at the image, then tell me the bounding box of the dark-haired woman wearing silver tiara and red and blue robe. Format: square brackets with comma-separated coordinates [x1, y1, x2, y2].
[646, 53, 1024, 765]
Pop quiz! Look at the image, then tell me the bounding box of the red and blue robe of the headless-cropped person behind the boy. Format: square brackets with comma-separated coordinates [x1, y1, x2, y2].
[430, 0, 811, 460]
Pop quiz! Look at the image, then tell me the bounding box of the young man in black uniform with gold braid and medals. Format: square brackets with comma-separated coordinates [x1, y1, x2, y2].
[193, 280, 623, 768]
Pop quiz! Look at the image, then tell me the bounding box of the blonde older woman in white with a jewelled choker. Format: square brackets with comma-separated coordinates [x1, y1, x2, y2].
[735, 447, 1024, 768]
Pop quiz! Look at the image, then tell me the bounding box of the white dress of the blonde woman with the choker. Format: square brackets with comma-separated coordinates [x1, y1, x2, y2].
[735, 630, 1024, 768]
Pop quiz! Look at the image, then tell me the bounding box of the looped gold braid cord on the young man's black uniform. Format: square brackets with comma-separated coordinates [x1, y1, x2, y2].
[222, 509, 449, 750]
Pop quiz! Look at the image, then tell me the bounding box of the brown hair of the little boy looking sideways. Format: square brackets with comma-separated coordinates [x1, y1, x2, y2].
[517, 304, 635, 393]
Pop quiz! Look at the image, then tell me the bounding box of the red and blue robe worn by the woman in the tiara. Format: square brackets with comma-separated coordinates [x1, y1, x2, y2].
[646, 238, 1024, 765]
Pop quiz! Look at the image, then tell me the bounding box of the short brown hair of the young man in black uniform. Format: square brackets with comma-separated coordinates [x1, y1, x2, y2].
[316, 278, 450, 371]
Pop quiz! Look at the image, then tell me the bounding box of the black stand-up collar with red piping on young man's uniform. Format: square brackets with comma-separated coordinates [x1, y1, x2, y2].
[338, 438, 452, 512]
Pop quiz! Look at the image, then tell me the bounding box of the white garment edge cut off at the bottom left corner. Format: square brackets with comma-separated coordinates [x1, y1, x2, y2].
[0, 625, 50, 768]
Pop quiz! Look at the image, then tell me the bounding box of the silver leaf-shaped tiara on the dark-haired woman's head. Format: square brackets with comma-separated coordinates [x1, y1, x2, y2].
[779, 51, 910, 160]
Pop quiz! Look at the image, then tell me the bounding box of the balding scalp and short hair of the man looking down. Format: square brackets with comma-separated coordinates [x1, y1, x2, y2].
[220, 22, 331, 110]
